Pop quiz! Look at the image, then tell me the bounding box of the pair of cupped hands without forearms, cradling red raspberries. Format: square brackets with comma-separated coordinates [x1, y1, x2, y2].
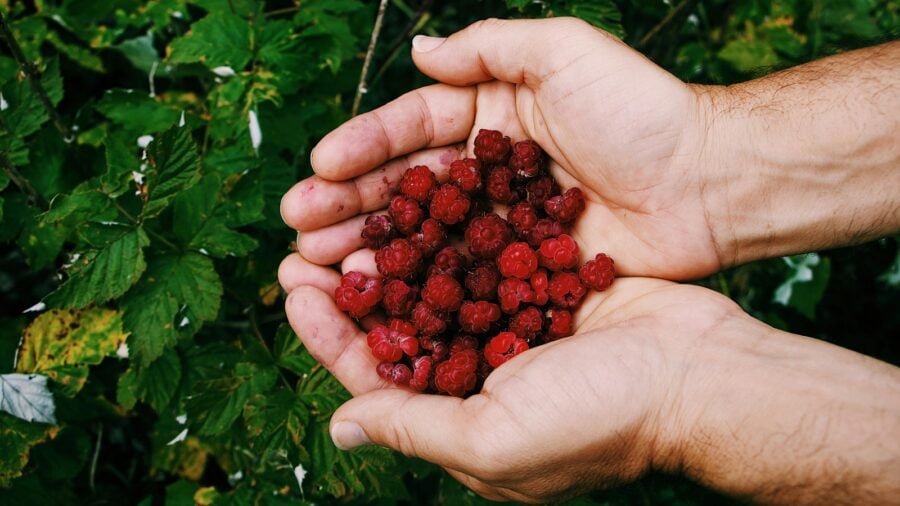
[279, 19, 880, 502]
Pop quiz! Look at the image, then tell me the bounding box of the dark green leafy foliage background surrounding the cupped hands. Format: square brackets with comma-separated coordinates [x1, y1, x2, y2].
[0, 0, 900, 505]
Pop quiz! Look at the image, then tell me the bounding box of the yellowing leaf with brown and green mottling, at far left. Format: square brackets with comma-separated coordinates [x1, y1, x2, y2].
[16, 308, 126, 397]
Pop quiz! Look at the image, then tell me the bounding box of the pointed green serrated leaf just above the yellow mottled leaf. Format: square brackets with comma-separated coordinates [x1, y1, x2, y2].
[44, 229, 149, 308]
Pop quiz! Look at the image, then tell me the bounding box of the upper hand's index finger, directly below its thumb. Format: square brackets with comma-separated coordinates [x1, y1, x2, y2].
[311, 84, 475, 181]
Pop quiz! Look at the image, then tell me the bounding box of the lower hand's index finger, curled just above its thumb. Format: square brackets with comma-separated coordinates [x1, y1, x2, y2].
[285, 285, 386, 395]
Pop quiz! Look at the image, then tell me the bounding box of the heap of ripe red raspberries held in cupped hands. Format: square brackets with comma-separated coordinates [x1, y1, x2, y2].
[334, 130, 615, 397]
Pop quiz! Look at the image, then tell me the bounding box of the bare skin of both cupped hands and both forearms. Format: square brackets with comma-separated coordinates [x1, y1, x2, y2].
[279, 19, 900, 504]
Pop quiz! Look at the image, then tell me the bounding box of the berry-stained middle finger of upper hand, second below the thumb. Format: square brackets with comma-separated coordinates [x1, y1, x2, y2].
[281, 143, 465, 231]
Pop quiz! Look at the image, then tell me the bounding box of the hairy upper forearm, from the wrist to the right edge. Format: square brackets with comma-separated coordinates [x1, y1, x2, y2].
[697, 42, 900, 266]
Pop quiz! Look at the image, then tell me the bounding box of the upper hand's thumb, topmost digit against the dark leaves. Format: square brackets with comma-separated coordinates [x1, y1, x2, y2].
[412, 18, 614, 86]
